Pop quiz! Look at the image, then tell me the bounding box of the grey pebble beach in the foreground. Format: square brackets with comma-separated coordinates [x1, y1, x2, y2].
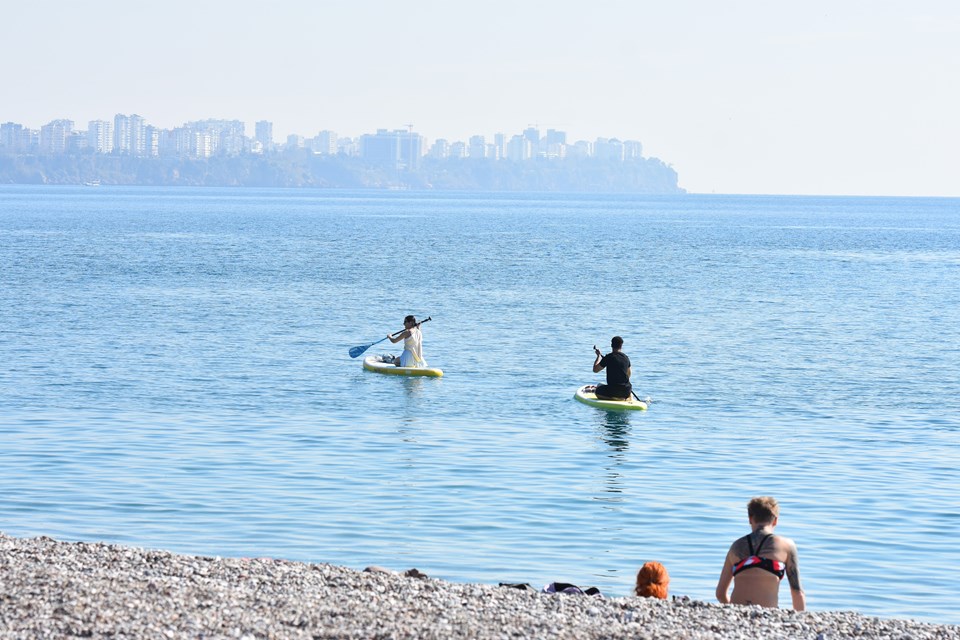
[0, 533, 960, 640]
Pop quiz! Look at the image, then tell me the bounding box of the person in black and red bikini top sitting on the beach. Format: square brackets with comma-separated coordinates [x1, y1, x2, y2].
[717, 497, 807, 611]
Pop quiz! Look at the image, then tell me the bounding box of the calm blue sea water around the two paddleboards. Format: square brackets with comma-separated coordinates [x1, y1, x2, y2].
[0, 186, 960, 623]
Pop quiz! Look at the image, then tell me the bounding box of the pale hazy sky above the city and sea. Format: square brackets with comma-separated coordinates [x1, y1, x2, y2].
[0, 0, 960, 196]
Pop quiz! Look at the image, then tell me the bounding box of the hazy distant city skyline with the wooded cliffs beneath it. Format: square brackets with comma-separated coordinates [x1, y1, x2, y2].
[0, 113, 684, 194]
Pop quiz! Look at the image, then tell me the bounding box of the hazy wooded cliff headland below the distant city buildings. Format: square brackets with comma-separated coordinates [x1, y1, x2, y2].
[0, 149, 684, 194]
